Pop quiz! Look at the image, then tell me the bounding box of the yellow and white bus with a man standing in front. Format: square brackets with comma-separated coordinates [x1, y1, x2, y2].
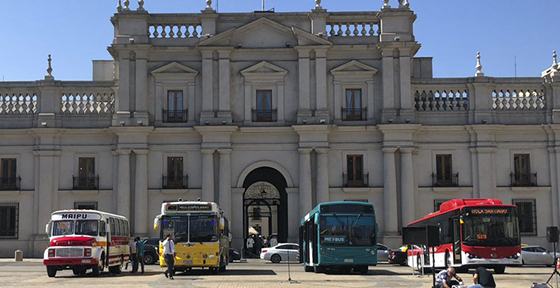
[154, 199, 231, 272]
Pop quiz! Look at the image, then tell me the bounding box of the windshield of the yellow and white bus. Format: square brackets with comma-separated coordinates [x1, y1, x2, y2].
[162, 215, 218, 243]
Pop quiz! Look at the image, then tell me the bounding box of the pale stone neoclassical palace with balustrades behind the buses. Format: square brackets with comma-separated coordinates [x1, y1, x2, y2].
[0, 1, 560, 257]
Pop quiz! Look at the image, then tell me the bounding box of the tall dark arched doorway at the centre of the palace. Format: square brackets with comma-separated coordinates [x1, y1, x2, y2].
[243, 167, 288, 251]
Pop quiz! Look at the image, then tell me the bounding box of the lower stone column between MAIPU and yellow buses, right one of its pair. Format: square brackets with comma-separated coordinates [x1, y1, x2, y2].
[134, 150, 150, 236]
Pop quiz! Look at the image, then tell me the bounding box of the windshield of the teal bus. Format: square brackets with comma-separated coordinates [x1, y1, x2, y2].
[319, 213, 375, 246]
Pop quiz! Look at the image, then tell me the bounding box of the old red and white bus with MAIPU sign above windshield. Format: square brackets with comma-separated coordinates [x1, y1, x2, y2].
[43, 210, 130, 277]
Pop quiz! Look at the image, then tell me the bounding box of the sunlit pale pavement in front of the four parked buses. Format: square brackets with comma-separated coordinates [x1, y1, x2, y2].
[0, 259, 553, 288]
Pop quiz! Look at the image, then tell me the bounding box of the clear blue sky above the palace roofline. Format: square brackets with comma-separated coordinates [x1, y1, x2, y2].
[0, 0, 560, 81]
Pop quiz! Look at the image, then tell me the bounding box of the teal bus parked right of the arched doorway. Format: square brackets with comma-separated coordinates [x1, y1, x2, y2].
[299, 201, 378, 274]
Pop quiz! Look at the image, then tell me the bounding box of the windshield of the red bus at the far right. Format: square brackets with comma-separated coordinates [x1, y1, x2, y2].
[463, 207, 520, 246]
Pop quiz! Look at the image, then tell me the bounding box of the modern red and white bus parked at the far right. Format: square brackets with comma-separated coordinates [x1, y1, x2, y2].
[407, 199, 522, 274]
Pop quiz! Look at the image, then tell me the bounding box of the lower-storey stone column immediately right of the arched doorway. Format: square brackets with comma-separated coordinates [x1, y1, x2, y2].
[299, 149, 313, 219]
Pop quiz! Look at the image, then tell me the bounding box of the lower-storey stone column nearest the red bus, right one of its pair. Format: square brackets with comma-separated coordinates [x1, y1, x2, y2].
[400, 148, 415, 227]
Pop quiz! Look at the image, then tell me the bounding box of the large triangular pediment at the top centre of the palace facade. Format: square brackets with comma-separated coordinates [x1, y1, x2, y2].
[198, 17, 332, 48]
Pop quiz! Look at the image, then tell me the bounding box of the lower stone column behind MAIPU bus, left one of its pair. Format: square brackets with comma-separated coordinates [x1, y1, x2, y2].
[117, 149, 131, 219]
